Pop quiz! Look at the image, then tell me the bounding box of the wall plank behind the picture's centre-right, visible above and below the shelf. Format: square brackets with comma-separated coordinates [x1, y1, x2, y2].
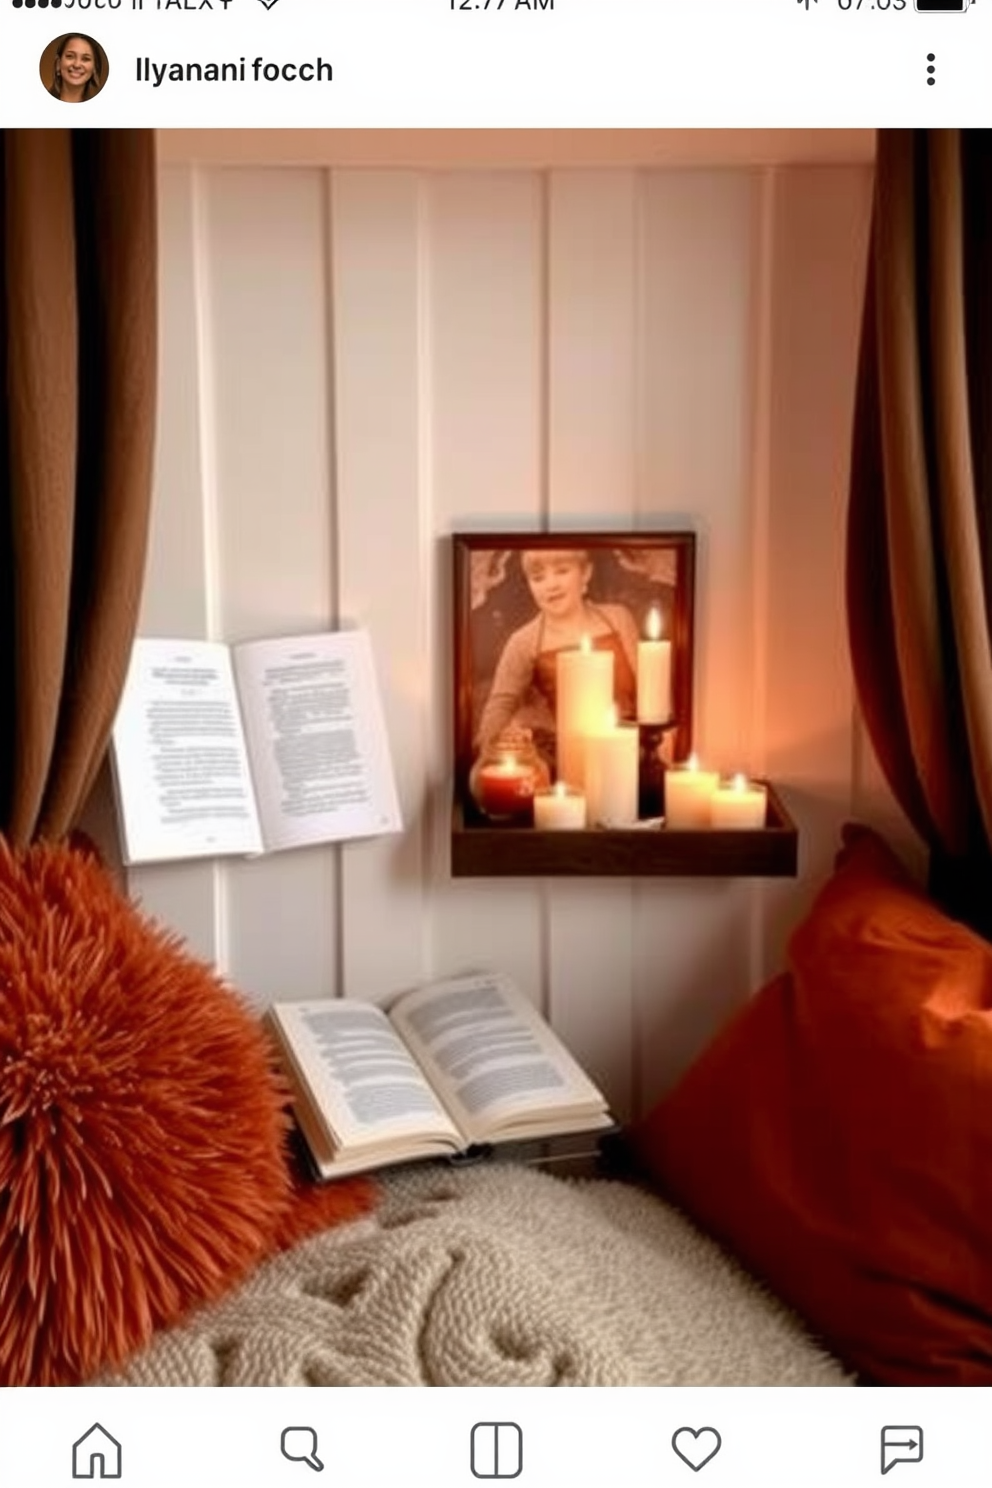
[546, 171, 638, 1116]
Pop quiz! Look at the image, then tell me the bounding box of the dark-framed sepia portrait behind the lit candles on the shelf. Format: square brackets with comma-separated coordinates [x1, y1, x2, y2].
[452, 533, 695, 799]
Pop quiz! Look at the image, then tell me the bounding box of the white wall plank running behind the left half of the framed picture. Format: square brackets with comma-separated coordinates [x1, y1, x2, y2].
[425, 173, 544, 995]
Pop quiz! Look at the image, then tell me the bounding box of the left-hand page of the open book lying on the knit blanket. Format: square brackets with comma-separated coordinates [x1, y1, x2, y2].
[271, 998, 460, 1150]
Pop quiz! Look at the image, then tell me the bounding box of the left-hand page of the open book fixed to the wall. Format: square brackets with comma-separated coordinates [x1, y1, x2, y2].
[112, 637, 262, 863]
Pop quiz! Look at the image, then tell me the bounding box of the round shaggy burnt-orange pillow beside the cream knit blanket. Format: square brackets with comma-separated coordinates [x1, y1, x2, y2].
[0, 839, 375, 1385]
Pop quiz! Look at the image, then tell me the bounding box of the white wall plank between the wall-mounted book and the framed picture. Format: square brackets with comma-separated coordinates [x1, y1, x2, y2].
[332, 171, 436, 998]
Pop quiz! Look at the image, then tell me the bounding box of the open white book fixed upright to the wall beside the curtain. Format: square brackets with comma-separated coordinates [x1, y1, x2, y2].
[110, 631, 400, 863]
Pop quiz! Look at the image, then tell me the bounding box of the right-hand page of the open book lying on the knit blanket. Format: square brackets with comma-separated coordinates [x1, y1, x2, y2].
[390, 973, 605, 1141]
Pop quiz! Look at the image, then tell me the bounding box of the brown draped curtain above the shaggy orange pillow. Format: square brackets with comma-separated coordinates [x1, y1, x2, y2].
[0, 129, 156, 845]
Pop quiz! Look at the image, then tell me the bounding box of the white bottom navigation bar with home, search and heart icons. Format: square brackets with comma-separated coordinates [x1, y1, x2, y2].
[0, 1388, 992, 1488]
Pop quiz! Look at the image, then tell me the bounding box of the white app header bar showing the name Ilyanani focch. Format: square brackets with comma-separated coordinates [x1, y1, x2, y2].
[0, 0, 992, 128]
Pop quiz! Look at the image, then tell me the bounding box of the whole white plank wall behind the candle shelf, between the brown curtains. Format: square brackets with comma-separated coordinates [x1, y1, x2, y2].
[129, 154, 877, 1115]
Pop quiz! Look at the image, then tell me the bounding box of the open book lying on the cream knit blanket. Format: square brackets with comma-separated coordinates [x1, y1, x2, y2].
[266, 975, 614, 1178]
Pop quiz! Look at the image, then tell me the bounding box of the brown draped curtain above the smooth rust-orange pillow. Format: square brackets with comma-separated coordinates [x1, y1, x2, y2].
[848, 129, 992, 934]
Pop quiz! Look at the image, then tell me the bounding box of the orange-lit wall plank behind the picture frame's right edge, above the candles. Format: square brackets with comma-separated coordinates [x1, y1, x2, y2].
[638, 171, 757, 769]
